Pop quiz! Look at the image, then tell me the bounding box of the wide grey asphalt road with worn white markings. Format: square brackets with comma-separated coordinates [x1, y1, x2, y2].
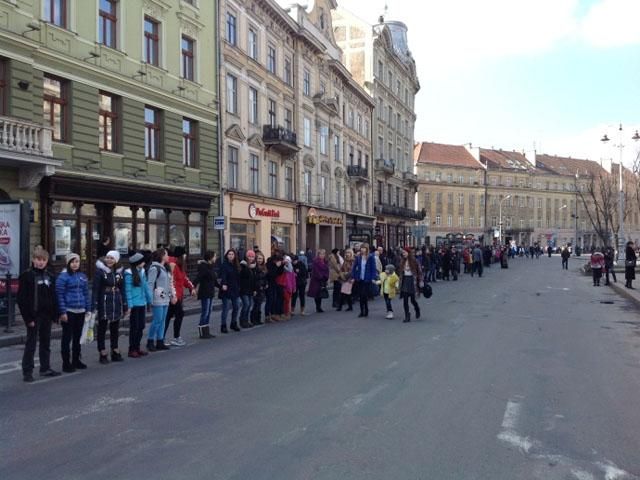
[0, 257, 640, 480]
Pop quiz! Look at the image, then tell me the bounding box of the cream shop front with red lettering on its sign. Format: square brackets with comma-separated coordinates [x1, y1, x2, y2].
[225, 194, 296, 257]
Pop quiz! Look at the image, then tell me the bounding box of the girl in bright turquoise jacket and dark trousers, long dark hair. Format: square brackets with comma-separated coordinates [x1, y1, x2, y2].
[124, 252, 153, 358]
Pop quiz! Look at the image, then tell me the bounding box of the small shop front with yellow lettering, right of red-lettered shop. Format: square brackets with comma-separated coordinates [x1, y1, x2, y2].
[300, 206, 345, 252]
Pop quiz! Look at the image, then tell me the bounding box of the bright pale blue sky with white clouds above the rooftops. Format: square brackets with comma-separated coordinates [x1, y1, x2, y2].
[338, 0, 640, 166]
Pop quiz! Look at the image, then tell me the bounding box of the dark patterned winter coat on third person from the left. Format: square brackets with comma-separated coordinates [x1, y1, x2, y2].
[93, 260, 128, 322]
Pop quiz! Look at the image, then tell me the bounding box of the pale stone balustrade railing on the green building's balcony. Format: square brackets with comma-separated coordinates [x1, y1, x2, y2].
[0, 117, 53, 157]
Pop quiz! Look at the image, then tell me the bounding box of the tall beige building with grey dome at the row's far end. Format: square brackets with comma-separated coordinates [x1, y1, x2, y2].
[333, 8, 424, 247]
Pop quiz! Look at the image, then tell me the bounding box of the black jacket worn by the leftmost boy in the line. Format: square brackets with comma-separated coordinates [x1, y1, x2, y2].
[16, 268, 58, 323]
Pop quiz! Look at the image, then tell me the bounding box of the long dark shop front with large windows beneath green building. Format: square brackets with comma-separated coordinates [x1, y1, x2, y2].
[41, 176, 214, 274]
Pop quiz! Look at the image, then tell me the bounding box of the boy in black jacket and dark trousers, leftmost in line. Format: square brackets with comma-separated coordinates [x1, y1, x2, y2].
[16, 247, 60, 383]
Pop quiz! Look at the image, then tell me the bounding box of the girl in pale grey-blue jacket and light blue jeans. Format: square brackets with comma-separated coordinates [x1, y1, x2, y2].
[147, 248, 176, 352]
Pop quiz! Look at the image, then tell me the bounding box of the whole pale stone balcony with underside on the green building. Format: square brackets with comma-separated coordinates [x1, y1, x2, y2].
[0, 116, 62, 189]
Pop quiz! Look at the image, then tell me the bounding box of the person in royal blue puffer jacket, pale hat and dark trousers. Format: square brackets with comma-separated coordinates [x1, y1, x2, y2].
[56, 253, 91, 373]
